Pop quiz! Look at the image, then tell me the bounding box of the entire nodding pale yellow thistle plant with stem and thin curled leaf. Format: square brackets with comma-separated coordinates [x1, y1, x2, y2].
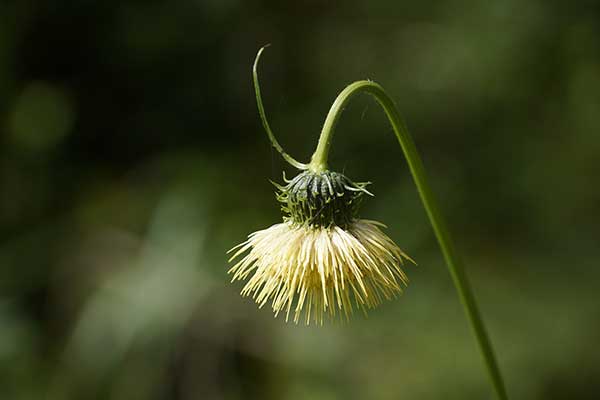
[229, 46, 508, 400]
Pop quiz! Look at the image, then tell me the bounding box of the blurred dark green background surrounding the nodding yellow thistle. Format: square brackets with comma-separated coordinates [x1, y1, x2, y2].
[0, 0, 600, 400]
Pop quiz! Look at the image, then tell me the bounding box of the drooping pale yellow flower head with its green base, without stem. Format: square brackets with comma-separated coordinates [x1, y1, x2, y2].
[229, 171, 414, 324]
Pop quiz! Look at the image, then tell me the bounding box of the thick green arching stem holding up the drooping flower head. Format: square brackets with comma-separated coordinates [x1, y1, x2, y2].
[308, 81, 507, 400]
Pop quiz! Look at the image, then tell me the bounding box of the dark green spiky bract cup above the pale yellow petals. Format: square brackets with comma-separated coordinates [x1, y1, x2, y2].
[273, 170, 372, 228]
